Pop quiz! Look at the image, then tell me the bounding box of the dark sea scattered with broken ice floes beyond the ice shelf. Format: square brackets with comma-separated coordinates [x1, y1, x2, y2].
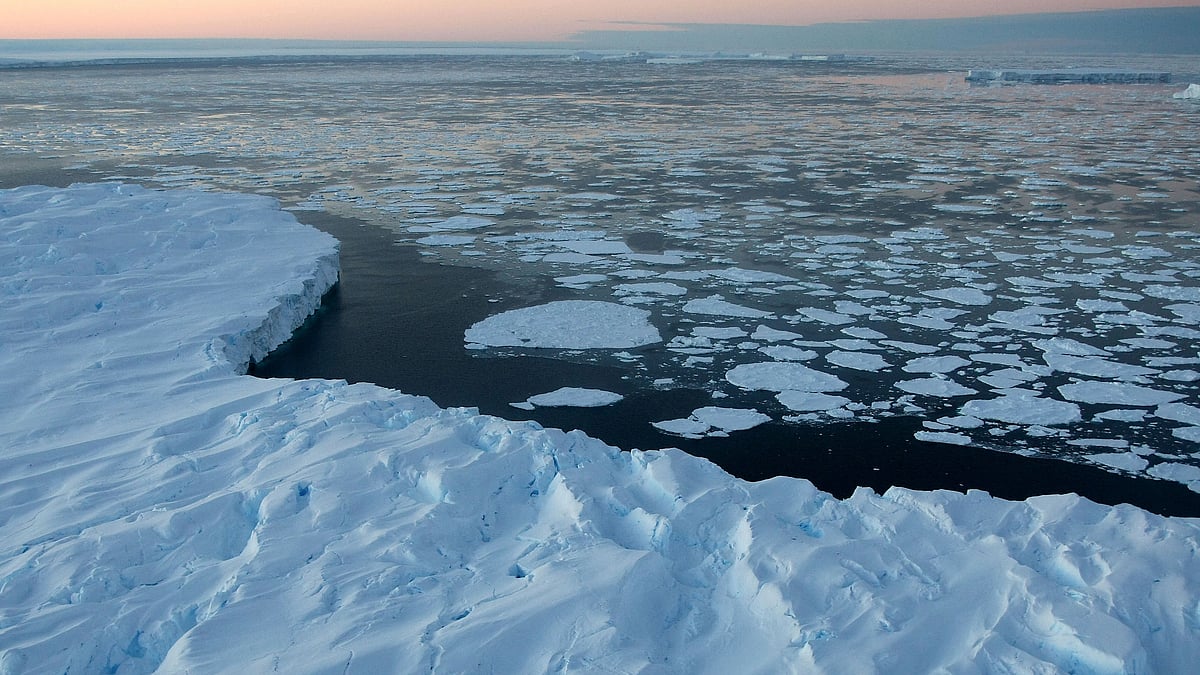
[7, 45, 1200, 515]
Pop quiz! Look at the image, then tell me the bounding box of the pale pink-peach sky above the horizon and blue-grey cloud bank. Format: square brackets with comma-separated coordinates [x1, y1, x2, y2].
[0, 0, 1200, 42]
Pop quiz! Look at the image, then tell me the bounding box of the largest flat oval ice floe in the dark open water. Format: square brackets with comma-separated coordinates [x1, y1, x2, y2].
[464, 300, 662, 350]
